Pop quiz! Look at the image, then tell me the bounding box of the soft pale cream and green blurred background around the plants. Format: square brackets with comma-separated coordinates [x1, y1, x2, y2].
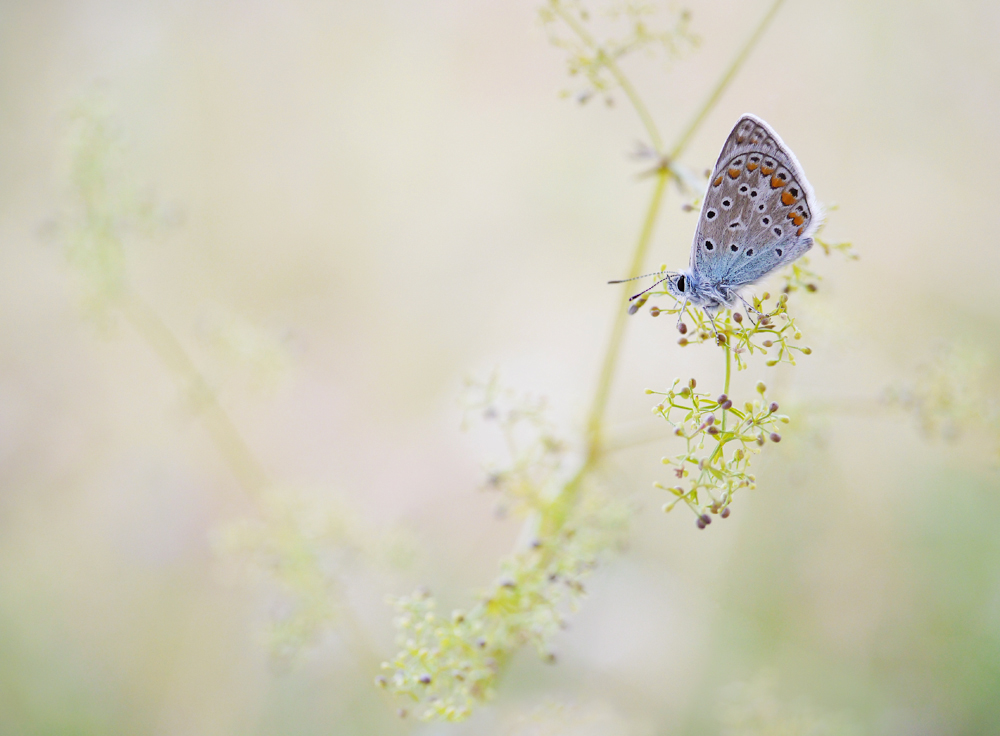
[0, 0, 1000, 735]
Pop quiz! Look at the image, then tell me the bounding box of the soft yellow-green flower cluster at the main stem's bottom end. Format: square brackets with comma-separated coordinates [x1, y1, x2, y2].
[376, 377, 628, 720]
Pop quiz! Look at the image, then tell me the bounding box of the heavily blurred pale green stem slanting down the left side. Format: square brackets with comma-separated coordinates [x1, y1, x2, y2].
[64, 106, 380, 669]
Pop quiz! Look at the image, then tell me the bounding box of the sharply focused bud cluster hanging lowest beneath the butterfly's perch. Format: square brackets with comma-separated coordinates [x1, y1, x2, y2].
[646, 378, 789, 529]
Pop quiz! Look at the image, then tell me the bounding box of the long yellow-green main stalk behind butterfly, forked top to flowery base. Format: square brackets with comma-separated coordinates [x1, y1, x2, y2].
[376, 0, 791, 720]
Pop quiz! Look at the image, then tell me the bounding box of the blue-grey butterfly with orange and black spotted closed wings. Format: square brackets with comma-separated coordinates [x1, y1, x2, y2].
[610, 115, 822, 317]
